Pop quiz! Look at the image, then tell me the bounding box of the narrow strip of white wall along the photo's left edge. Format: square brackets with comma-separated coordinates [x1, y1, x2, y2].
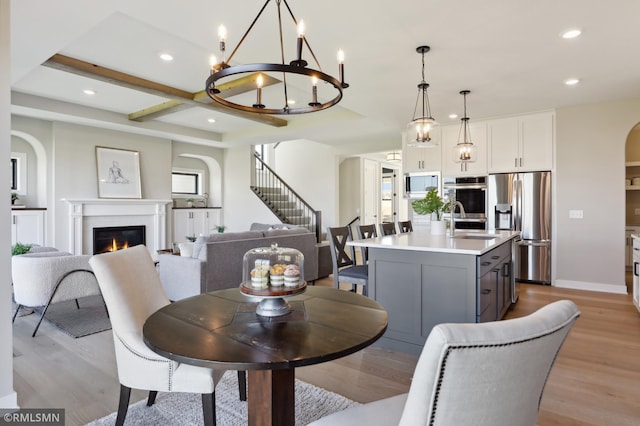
[0, 0, 18, 408]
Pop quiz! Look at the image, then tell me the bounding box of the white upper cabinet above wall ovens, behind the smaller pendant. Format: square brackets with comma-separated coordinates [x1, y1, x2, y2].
[442, 122, 487, 177]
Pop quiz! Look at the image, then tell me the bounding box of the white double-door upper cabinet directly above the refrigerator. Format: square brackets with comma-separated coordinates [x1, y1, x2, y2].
[487, 112, 554, 173]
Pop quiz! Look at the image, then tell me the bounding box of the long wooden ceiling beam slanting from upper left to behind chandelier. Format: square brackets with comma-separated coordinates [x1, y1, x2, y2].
[42, 54, 287, 127]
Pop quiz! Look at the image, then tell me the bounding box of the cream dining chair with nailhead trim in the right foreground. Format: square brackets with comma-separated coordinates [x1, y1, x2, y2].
[311, 300, 580, 426]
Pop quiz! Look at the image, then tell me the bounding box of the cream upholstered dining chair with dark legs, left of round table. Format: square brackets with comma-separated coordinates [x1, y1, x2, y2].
[89, 245, 230, 425]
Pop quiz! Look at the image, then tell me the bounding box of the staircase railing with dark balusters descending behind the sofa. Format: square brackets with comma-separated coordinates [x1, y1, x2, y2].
[251, 154, 322, 242]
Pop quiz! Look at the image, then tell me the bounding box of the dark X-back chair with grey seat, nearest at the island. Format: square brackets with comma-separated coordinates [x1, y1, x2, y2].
[327, 226, 369, 296]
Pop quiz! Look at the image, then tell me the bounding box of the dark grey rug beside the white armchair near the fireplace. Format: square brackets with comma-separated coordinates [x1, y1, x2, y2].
[34, 295, 111, 338]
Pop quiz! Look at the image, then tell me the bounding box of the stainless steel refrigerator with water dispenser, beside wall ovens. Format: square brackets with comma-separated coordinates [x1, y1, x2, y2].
[487, 172, 551, 292]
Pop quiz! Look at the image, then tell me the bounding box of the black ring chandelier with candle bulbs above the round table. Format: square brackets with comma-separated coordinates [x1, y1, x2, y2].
[205, 0, 349, 114]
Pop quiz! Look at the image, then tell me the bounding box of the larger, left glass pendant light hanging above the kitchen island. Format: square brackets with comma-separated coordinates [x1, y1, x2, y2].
[407, 46, 438, 148]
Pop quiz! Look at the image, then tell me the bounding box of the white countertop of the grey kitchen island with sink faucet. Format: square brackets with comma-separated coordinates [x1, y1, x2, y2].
[347, 229, 520, 255]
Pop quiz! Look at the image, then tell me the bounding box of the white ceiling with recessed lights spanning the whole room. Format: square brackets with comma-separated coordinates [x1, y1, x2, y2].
[11, 0, 640, 154]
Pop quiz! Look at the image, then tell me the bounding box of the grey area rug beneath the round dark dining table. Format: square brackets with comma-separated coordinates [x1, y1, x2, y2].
[87, 371, 359, 426]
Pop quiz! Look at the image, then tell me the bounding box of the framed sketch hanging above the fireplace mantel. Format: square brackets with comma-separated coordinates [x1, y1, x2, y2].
[96, 146, 142, 198]
